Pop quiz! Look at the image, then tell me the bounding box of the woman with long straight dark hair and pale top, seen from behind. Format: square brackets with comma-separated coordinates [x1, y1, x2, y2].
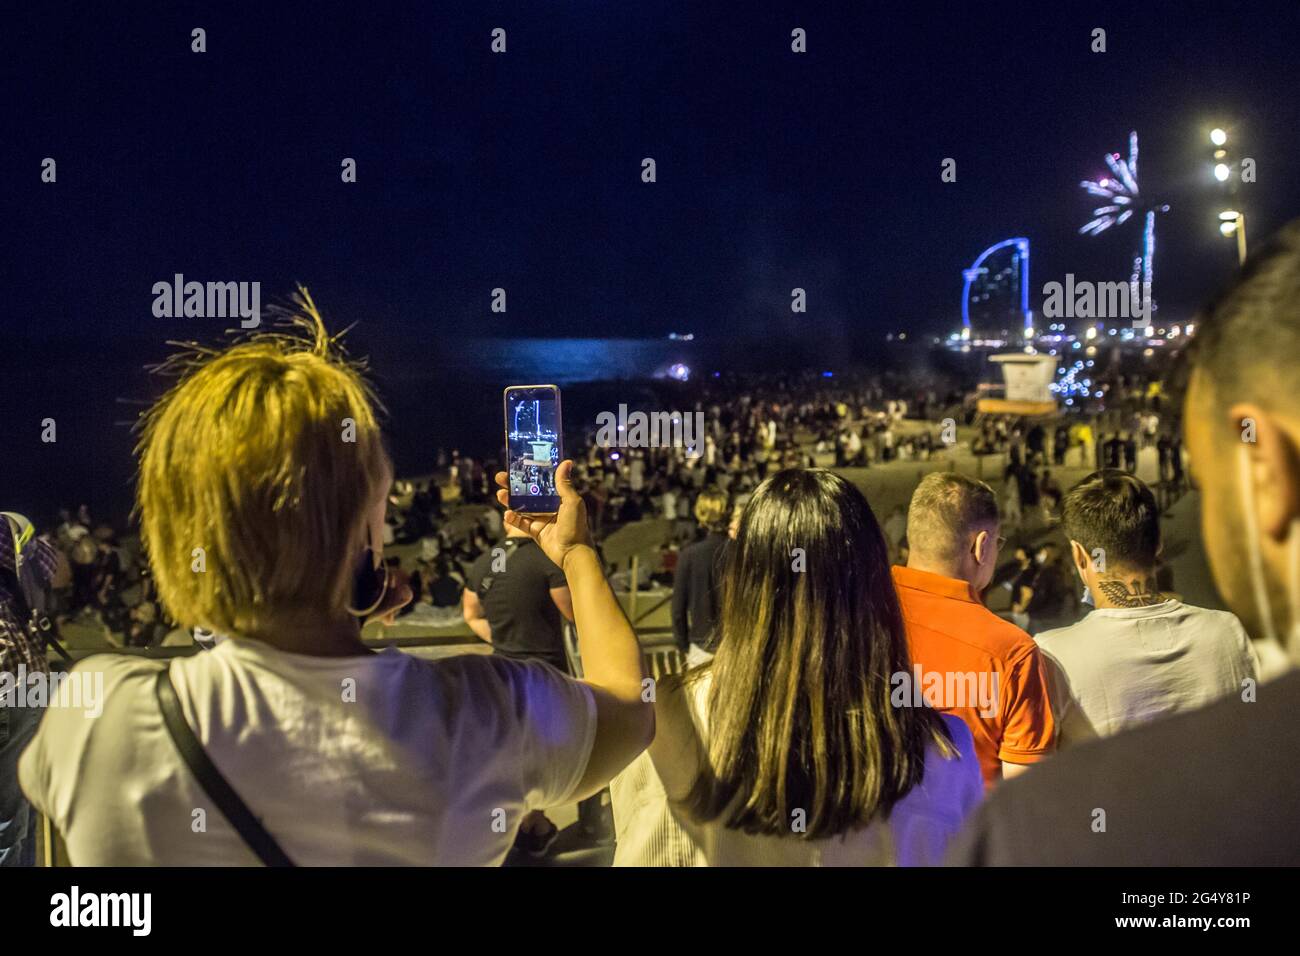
[611, 470, 983, 866]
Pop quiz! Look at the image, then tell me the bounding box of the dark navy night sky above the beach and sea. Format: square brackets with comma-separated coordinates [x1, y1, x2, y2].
[0, 0, 1300, 515]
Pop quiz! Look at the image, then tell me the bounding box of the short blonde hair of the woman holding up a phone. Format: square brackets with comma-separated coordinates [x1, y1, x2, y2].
[137, 287, 386, 635]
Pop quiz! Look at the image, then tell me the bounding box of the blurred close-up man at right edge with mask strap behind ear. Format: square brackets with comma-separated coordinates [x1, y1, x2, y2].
[949, 220, 1300, 866]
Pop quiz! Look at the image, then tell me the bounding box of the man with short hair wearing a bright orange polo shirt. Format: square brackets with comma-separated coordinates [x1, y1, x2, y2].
[893, 472, 1056, 788]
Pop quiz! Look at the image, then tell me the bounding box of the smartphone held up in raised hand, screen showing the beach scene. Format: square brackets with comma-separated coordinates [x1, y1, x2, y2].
[504, 385, 564, 515]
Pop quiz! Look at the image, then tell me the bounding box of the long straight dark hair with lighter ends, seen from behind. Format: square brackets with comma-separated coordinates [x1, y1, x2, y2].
[683, 468, 954, 839]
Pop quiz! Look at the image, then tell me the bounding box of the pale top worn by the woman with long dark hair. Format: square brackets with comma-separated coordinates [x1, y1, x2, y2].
[610, 675, 984, 866]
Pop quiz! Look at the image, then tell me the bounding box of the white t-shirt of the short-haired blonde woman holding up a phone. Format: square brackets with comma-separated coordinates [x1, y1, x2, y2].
[18, 639, 595, 866]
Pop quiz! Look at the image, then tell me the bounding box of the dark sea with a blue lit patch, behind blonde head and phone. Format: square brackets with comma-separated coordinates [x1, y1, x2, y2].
[0, 330, 822, 527]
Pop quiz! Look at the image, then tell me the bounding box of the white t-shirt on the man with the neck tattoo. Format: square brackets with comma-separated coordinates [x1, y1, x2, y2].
[1034, 600, 1257, 747]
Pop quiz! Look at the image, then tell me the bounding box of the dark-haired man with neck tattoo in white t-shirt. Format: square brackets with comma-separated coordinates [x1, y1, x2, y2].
[1035, 468, 1257, 748]
